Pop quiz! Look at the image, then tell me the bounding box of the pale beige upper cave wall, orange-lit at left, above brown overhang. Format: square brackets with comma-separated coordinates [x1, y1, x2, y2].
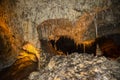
[0, 0, 116, 48]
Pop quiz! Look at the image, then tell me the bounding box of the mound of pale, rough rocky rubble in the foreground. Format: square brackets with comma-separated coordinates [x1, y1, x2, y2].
[28, 53, 120, 80]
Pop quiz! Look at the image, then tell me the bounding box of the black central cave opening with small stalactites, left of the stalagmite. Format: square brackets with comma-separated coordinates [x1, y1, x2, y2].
[50, 36, 96, 54]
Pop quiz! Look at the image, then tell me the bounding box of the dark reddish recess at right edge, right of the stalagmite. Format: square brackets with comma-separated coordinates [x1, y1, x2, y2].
[96, 34, 120, 59]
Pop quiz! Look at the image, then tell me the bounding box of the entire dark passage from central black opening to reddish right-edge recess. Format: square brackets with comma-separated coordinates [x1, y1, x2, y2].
[50, 34, 120, 59]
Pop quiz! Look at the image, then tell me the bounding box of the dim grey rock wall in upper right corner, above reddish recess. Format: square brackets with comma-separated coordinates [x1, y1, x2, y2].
[96, 0, 120, 36]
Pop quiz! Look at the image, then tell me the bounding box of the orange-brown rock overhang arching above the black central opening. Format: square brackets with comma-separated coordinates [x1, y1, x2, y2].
[37, 11, 97, 44]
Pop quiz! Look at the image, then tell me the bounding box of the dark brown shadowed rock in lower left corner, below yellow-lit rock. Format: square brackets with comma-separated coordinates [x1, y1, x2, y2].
[0, 57, 37, 80]
